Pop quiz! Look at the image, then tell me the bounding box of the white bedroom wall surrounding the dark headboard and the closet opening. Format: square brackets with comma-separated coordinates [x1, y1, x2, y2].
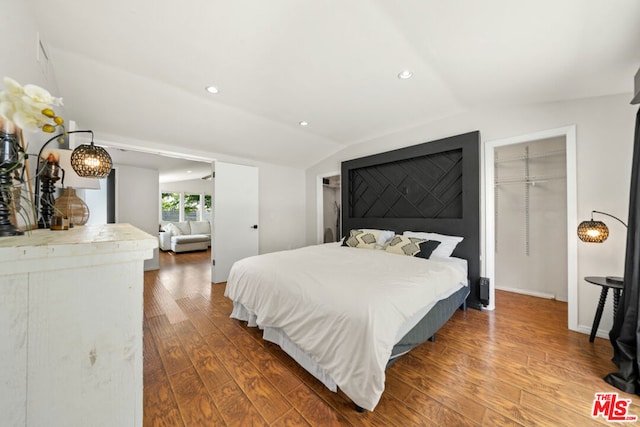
[306, 94, 637, 336]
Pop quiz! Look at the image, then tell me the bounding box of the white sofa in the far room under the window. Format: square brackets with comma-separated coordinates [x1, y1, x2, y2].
[158, 221, 211, 253]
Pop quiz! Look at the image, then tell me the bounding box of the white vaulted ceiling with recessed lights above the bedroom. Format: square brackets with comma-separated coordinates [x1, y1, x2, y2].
[27, 0, 640, 167]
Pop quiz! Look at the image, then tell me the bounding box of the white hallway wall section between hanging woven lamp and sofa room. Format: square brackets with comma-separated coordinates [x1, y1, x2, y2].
[114, 165, 160, 270]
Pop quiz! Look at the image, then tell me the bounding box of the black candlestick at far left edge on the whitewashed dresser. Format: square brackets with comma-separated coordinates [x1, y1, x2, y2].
[0, 129, 24, 237]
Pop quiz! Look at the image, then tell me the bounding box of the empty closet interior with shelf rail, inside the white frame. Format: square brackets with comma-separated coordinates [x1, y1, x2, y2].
[494, 136, 568, 302]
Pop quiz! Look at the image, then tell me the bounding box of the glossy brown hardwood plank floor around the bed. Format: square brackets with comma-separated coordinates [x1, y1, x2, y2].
[144, 252, 640, 426]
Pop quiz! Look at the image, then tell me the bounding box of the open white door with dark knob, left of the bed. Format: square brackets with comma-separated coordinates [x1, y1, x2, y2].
[211, 162, 258, 283]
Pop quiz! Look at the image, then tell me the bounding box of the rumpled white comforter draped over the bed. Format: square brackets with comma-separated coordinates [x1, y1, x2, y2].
[225, 243, 467, 410]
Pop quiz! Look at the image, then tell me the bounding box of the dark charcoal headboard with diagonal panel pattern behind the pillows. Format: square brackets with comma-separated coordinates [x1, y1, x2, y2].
[342, 131, 481, 308]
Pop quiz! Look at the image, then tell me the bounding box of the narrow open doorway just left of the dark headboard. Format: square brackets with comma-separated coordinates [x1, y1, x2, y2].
[316, 172, 342, 243]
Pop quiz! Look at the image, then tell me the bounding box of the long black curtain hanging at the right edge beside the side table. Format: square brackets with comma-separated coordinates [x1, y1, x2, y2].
[605, 105, 640, 394]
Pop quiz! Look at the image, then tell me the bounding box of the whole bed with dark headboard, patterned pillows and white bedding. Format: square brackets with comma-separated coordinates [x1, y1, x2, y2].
[225, 132, 481, 410]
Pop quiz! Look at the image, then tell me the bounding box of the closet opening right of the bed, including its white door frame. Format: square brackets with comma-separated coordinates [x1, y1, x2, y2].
[483, 126, 578, 331]
